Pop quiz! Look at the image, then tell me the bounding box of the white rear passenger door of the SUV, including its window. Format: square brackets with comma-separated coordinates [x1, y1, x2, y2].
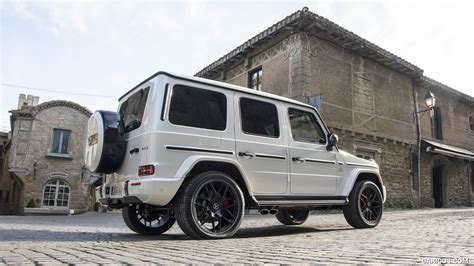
[234, 93, 289, 195]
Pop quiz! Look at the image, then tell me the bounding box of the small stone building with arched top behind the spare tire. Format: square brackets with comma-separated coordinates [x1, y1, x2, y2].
[0, 95, 99, 214]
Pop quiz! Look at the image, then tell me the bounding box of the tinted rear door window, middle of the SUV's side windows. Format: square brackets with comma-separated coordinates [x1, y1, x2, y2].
[240, 98, 280, 138]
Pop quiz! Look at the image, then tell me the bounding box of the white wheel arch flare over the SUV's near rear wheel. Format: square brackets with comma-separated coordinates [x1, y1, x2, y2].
[172, 157, 257, 206]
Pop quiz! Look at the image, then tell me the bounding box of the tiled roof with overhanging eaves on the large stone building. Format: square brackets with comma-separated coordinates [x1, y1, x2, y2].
[196, 7, 423, 78]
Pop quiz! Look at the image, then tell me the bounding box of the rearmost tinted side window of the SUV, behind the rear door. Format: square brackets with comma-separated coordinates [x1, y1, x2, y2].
[169, 85, 227, 130]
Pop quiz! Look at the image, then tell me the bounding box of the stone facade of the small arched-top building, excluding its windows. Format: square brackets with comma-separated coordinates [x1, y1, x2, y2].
[10, 101, 93, 214]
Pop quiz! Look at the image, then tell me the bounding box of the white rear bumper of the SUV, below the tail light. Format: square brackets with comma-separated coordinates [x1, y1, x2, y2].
[96, 177, 183, 208]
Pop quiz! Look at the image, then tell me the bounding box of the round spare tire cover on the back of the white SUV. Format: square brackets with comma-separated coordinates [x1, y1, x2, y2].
[84, 111, 126, 174]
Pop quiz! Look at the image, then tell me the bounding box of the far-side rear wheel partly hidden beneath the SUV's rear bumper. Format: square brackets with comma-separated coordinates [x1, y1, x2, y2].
[122, 204, 176, 235]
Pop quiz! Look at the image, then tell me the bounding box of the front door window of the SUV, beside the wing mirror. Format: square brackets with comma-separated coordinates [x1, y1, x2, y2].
[288, 108, 326, 144]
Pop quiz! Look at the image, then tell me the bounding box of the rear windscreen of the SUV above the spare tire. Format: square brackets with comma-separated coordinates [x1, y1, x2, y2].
[119, 87, 150, 132]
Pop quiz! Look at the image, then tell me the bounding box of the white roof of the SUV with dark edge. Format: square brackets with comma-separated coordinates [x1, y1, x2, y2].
[119, 71, 314, 109]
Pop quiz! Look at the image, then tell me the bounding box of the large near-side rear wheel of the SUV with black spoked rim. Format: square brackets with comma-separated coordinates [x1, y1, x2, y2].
[174, 171, 245, 239]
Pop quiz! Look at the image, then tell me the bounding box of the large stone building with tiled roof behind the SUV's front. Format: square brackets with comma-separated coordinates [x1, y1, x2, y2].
[196, 8, 474, 207]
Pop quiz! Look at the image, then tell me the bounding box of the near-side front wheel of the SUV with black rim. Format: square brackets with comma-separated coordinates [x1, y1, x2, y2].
[342, 180, 383, 228]
